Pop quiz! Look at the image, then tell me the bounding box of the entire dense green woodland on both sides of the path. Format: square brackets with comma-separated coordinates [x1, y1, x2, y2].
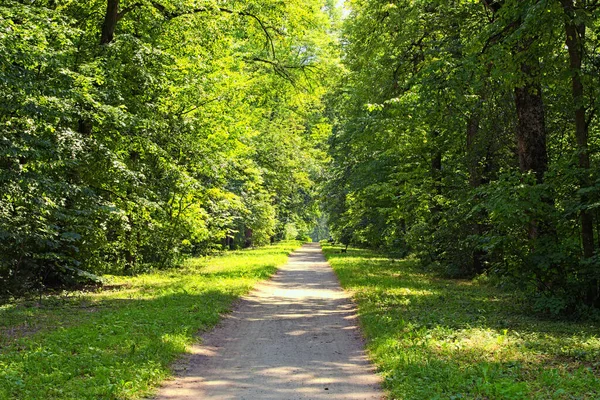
[0, 0, 600, 313]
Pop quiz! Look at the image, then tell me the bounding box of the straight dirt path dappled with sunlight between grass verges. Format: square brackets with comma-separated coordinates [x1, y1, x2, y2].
[157, 244, 383, 400]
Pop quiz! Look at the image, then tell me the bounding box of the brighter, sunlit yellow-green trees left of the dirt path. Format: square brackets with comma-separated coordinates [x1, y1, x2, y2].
[0, 0, 335, 295]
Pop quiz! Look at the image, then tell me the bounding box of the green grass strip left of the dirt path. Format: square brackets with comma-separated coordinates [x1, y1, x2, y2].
[0, 242, 300, 400]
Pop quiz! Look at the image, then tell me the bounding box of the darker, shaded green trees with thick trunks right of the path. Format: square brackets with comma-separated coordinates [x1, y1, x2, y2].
[326, 0, 600, 313]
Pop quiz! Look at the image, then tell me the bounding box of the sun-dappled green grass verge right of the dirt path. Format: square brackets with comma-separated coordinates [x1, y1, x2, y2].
[324, 245, 600, 400]
